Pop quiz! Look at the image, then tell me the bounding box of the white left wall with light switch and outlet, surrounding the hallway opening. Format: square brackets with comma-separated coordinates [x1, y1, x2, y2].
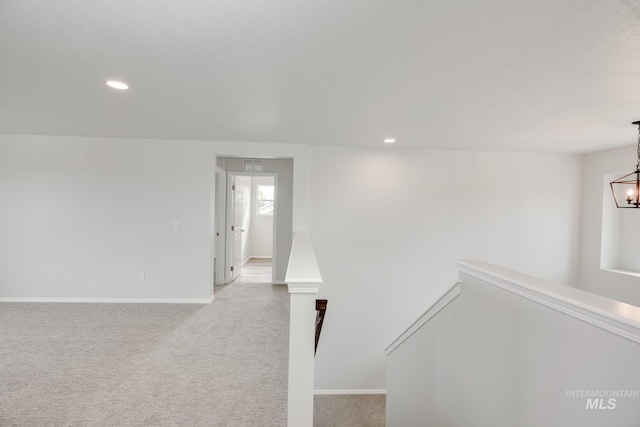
[0, 135, 307, 301]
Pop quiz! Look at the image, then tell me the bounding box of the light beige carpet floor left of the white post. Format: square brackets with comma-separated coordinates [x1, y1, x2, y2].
[0, 260, 289, 427]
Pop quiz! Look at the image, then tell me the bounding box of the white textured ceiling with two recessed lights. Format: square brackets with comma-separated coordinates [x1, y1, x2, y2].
[0, 0, 640, 152]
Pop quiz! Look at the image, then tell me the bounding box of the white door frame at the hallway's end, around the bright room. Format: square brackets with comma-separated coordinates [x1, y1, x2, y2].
[224, 171, 278, 283]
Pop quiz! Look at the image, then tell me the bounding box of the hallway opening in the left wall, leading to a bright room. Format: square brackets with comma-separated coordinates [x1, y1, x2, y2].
[212, 156, 293, 285]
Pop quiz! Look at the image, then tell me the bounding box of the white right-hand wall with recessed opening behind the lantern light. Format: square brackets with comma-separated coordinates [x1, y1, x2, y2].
[579, 146, 640, 306]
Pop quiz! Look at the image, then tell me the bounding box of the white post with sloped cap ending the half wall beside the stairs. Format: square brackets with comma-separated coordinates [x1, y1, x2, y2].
[287, 231, 322, 427]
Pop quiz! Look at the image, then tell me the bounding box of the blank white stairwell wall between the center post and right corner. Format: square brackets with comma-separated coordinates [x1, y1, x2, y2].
[308, 147, 581, 390]
